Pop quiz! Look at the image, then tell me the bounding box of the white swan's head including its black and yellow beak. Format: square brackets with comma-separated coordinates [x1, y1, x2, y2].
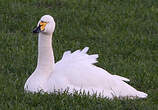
[33, 15, 55, 34]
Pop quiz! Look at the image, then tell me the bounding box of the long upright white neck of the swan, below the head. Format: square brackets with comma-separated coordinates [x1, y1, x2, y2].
[36, 33, 54, 74]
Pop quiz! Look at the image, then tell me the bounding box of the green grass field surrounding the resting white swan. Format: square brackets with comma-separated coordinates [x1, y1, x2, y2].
[0, 0, 158, 110]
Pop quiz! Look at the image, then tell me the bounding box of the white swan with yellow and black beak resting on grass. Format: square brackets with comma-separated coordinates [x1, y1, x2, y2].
[24, 15, 147, 99]
